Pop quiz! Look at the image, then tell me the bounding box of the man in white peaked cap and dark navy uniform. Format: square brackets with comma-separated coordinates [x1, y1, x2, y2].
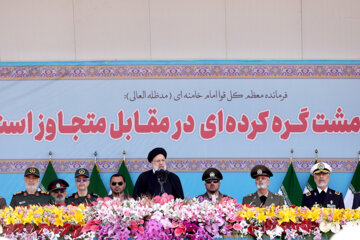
[301, 162, 345, 208]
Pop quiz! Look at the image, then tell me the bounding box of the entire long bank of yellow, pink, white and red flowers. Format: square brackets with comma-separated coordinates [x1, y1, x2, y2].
[0, 194, 360, 239]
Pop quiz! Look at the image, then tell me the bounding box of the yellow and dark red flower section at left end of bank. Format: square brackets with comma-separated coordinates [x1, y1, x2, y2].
[0, 205, 90, 240]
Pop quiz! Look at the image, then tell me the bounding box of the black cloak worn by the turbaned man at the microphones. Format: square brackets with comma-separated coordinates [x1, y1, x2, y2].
[133, 170, 184, 199]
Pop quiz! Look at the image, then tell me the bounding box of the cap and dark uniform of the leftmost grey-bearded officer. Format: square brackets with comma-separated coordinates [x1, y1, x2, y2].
[10, 167, 51, 208]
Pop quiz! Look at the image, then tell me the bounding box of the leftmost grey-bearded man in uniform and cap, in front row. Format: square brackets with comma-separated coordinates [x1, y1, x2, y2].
[10, 167, 51, 208]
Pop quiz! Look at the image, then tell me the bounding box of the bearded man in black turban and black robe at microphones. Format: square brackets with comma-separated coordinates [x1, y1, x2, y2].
[133, 148, 184, 199]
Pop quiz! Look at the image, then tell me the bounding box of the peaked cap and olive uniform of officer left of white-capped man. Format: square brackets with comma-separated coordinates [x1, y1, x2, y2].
[242, 165, 284, 207]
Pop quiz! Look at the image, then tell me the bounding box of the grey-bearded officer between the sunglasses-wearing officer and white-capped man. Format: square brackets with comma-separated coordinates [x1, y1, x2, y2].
[242, 165, 284, 207]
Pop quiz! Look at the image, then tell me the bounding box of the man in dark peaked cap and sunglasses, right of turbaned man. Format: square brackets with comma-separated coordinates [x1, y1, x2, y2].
[196, 168, 228, 202]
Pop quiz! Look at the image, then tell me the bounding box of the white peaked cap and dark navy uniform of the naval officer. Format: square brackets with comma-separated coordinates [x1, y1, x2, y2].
[301, 162, 345, 208]
